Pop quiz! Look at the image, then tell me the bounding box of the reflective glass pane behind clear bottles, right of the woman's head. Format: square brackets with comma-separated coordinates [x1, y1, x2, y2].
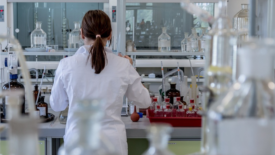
[126, 3, 215, 51]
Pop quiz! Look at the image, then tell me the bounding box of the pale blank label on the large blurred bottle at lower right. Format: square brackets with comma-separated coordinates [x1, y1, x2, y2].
[216, 118, 275, 155]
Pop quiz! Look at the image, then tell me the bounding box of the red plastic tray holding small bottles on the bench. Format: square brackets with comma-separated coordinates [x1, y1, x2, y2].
[146, 110, 201, 127]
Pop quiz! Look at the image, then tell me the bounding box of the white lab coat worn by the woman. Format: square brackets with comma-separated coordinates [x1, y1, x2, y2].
[50, 46, 151, 155]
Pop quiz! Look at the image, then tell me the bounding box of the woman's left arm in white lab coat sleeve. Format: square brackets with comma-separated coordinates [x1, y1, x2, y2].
[50, 60, 69, 111]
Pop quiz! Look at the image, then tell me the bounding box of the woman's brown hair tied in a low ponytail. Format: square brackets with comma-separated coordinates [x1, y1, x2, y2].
[81, 10, 112, 74]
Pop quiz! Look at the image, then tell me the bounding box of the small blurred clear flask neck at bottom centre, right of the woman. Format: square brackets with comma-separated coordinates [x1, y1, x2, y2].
[142, 124, 174, 155]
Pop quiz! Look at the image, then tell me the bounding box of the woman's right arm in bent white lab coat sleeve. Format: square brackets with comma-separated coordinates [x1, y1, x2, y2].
[125, 64, 151, 108]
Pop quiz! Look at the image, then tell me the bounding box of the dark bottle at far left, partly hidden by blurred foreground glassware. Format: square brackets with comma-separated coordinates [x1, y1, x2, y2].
[2, 74, 26, 119]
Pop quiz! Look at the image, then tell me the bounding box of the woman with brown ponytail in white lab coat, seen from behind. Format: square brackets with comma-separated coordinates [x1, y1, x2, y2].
[50, 10, 151, 155]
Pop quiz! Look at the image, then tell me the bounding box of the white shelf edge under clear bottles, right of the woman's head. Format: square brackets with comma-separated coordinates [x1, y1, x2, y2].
[126, 50, 204, 56]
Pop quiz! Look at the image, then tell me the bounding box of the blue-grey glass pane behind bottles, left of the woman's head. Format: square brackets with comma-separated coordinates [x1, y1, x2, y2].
[13, 2, 105, 49]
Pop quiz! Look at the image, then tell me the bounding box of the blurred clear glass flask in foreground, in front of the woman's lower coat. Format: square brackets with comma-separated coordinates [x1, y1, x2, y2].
[58, 100, 117, 155]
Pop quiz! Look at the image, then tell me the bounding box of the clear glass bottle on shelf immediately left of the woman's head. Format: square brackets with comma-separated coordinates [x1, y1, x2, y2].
[69, 22, 82, 48]
